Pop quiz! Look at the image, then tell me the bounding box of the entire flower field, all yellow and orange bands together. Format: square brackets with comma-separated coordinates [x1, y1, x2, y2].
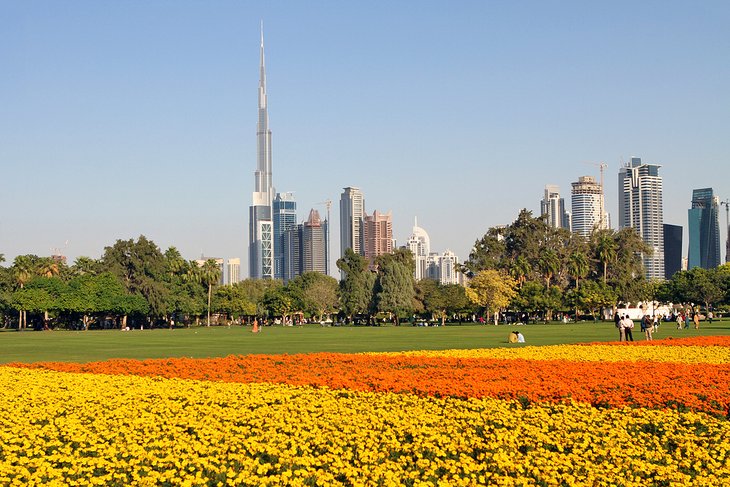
[0, 338, 730, 486]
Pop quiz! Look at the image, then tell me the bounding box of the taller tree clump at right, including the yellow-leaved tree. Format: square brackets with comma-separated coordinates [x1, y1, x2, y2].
[462, 210, 730, 318]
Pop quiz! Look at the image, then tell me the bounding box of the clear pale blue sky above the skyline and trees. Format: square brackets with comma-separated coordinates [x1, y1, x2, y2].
[0, 0, 730, 272]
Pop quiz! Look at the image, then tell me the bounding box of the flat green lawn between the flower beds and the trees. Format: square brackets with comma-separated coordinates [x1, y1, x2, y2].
[0, 320, 730, 363]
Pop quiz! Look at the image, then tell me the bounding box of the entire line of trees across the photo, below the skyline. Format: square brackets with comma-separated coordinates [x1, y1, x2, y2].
[0, 210, 730, 329]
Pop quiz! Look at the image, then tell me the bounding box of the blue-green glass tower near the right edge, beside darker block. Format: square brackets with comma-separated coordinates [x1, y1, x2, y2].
[687, 188, 720, 269]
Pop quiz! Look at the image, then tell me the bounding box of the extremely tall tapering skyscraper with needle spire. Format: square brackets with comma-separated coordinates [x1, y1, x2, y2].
[248, 28, 274, 279]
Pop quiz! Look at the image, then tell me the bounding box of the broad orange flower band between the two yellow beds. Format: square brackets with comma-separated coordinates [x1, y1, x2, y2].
[9, 352, 730, 416]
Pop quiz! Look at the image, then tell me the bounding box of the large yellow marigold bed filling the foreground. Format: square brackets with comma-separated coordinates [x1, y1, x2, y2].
[0, 367, 730, 486]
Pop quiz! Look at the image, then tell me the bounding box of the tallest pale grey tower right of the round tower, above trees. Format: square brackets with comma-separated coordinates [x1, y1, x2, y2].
[618, 157, 664, 279]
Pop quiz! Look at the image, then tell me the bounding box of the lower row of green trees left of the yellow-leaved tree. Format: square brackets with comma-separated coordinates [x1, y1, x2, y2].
[0, 236, 468, 329]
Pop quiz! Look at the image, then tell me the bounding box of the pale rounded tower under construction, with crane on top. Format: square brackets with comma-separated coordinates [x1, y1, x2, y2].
[571, 176, 609, 237]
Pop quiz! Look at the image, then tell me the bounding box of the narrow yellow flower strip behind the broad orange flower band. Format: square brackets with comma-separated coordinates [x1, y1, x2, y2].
[370, 344, 730, 364]
